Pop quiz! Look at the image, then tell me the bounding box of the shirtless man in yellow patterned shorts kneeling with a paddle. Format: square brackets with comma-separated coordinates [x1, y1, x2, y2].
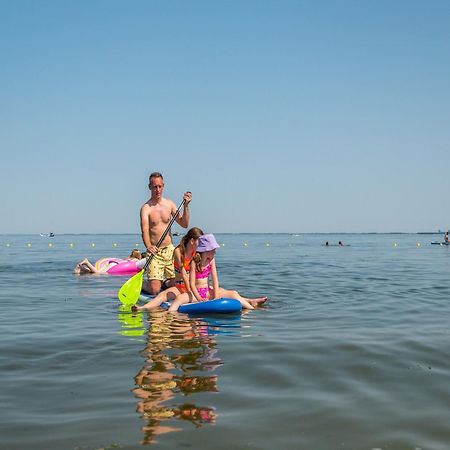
[141, 172, 192, 295]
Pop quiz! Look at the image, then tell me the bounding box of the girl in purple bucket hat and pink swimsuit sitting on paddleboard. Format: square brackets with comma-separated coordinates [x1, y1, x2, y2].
[169, 234, 267, 311]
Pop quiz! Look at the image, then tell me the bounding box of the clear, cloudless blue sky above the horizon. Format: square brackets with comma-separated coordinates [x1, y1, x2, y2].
[0, 0, 450, 234]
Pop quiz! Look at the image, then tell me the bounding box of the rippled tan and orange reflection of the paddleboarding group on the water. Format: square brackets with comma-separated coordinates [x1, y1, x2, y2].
[133, 311, 227, 444]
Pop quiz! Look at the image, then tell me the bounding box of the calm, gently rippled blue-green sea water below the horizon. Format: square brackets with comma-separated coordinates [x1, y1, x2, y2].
[0, 234, 450, 450]
